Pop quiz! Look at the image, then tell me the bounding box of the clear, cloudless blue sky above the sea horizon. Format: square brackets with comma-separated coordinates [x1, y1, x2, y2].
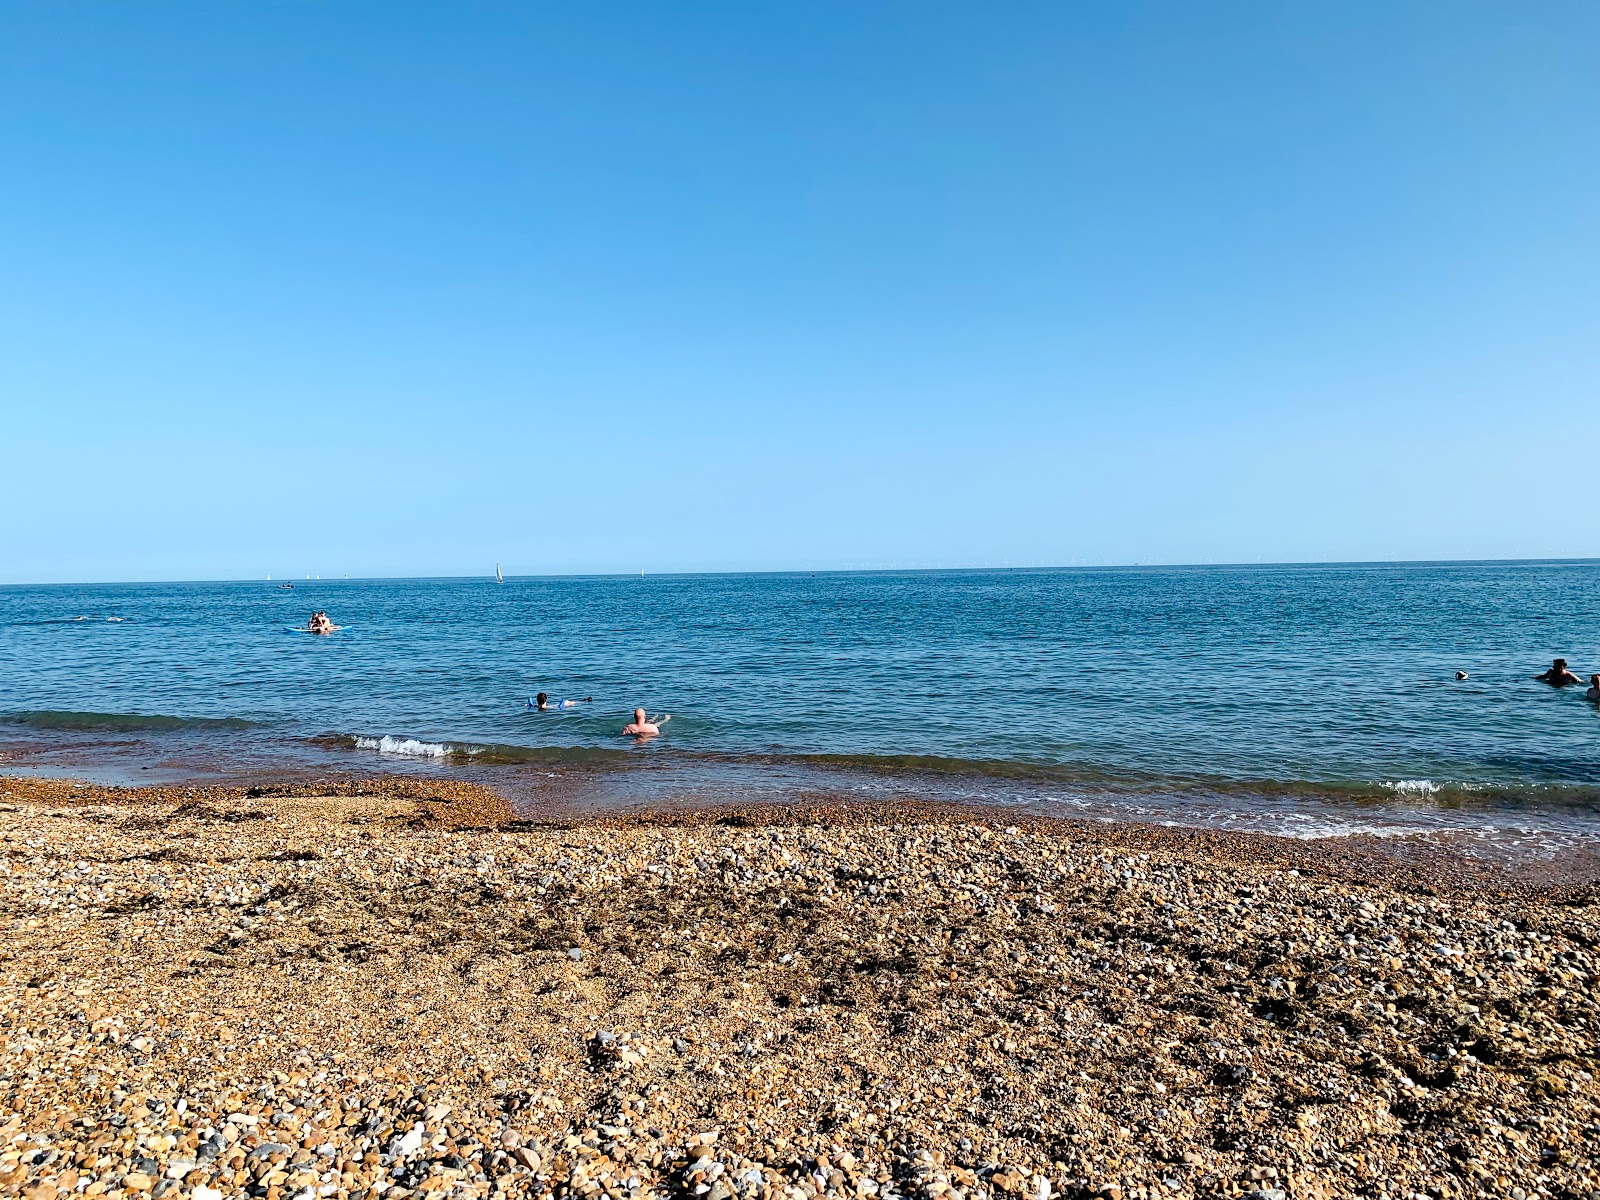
[0, 0, 1600, 582]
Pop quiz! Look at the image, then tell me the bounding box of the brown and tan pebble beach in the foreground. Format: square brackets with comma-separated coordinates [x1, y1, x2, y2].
[0, 779, 1600, 1200]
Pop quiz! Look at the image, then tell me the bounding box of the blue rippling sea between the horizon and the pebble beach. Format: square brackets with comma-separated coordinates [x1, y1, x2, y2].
[0, 560, 1600, 862]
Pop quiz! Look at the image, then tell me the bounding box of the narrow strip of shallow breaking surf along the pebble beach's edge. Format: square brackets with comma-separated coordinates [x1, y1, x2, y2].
[9, 742, 1600, 886]
